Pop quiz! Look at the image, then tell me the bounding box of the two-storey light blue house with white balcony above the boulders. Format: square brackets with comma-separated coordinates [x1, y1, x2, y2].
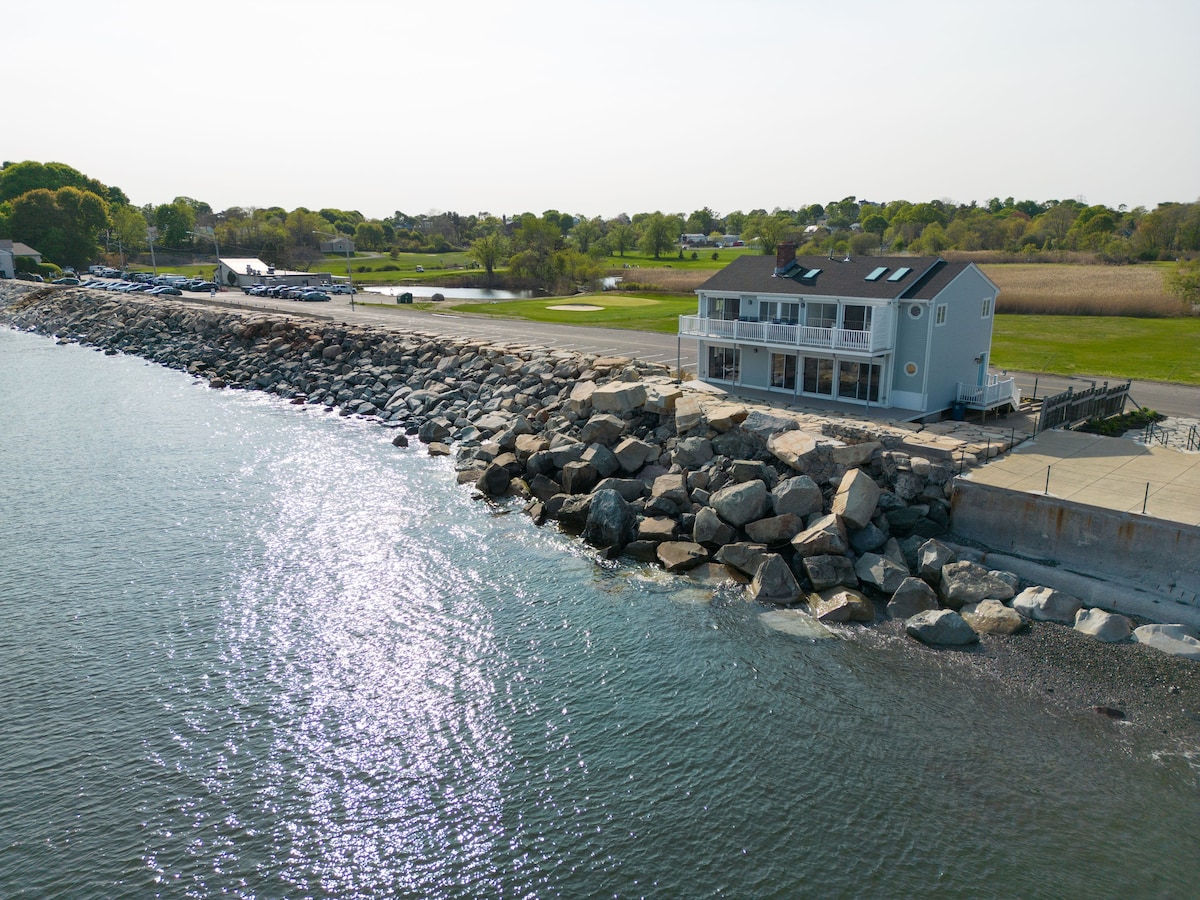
[679, 244, 1019, 419]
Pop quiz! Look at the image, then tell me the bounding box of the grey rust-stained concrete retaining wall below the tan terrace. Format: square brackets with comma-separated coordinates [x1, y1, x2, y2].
[950, 479, 1200, 606]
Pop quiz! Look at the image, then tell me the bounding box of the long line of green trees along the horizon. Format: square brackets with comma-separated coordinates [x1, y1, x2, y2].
[0, 161, 1200, 303]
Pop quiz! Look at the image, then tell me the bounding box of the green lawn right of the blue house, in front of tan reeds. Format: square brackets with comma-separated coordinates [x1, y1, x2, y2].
[991, 316, 1200, 384]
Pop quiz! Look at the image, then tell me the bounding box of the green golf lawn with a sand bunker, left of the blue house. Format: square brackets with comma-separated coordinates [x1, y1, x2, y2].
[445, 293, 696, 334]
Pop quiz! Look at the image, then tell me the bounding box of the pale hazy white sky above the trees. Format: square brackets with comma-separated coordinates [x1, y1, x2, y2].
[0, 0, 1200, 217]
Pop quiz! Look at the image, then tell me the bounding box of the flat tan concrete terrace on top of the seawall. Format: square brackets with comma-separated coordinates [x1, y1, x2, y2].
[965, 430, 1200, 526]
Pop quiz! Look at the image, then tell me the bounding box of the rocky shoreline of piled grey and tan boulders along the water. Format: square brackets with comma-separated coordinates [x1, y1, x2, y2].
[0, 286, 1200, 745]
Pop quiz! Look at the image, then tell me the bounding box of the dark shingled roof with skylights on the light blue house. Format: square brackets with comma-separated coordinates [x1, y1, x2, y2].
[698, 254, 970, 300]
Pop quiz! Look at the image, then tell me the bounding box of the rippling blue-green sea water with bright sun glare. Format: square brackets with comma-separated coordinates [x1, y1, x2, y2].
[0, 330, 1200, 898]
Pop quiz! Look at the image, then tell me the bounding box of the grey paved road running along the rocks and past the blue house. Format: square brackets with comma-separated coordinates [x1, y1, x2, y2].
[196, 293, 1200, 419]
